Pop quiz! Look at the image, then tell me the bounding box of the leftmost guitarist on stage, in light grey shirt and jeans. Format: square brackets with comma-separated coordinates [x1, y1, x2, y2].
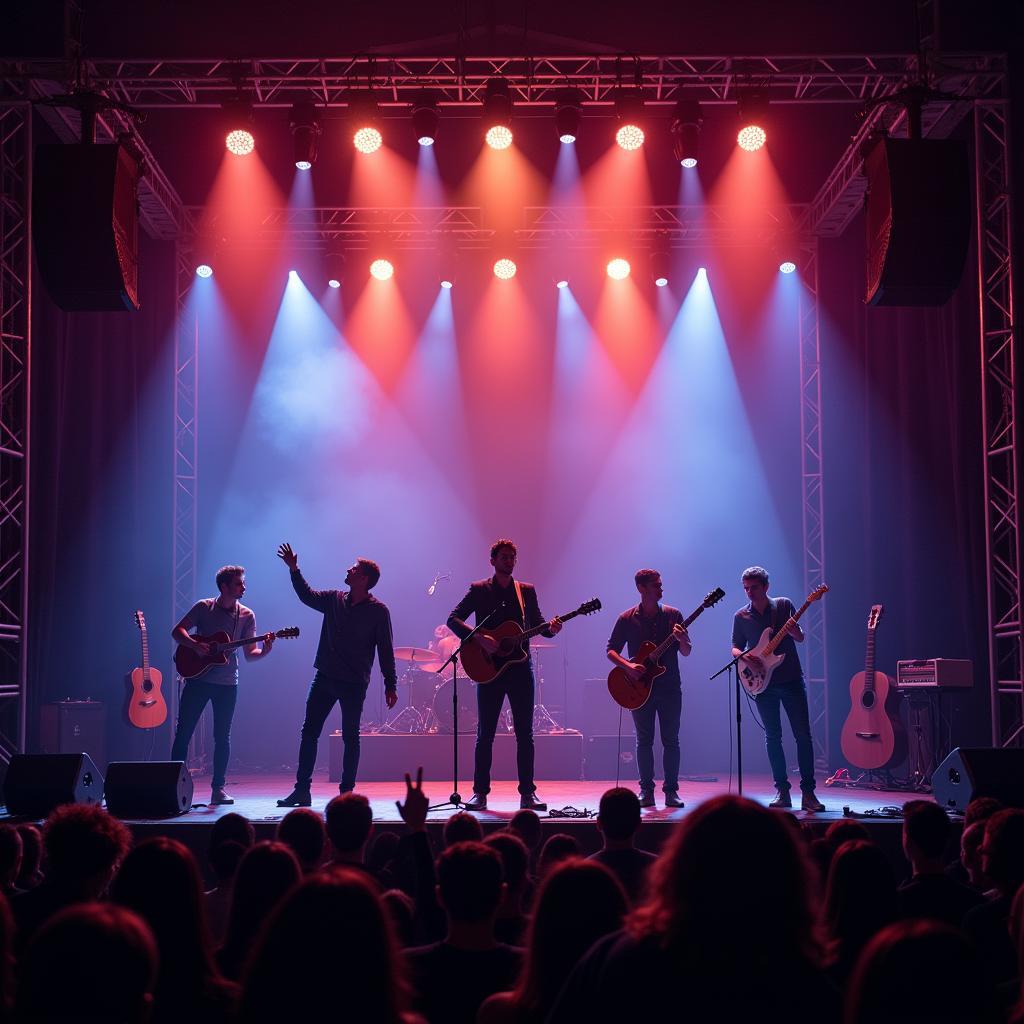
[171, 565, 273, 804]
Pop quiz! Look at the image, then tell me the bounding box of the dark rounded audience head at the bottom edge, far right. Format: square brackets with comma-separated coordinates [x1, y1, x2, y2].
[844, 921, 1001, 1024]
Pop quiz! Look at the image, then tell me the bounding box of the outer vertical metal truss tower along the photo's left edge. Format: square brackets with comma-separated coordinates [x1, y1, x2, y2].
[0, 102, 32, 764]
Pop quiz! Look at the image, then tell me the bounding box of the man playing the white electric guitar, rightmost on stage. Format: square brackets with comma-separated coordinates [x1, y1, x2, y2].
[732, 565, 825, 811]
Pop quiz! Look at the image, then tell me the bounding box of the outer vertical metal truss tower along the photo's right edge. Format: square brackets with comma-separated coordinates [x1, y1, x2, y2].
[974, 100, 1024, 746]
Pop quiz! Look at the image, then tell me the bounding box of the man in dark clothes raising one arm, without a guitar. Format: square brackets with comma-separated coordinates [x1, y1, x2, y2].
[278, 544, 398, 807]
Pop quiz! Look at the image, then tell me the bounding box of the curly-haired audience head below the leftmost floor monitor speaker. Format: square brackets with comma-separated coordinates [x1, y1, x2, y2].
[43, 804, 131, 899]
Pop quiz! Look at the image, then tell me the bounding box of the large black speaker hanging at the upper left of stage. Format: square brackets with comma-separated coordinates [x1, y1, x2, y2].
[32, 145, 139, 311]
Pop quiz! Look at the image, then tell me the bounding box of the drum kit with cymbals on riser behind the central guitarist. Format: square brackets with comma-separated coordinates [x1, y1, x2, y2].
[380, 641, 562, 736]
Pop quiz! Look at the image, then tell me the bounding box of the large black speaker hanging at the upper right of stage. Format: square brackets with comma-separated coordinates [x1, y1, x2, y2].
[864, 138, 971, 306]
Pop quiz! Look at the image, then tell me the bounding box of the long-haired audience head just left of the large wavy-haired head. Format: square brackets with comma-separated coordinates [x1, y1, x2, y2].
[515, 859, 627, 1020]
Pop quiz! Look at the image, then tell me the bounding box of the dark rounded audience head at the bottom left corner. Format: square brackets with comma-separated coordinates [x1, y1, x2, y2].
[16, 903, 158, 1024]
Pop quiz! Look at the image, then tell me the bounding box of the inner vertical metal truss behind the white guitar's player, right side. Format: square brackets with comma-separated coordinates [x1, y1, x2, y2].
[800, 239, 830, 770]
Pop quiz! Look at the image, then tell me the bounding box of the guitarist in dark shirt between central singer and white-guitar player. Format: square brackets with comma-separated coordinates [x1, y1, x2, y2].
[608, 569, 693, 807]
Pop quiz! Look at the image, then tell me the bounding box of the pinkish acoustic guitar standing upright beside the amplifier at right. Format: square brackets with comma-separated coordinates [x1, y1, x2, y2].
[842, 604, 906, 770]
